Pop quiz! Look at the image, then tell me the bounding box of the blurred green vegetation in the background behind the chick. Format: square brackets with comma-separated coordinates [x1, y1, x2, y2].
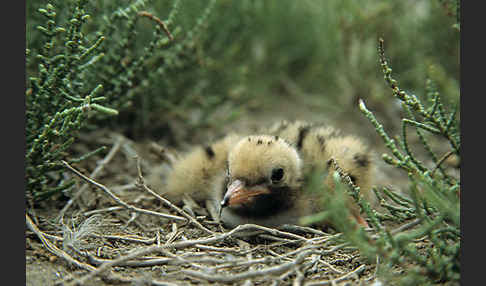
[26, 0, 460, 144]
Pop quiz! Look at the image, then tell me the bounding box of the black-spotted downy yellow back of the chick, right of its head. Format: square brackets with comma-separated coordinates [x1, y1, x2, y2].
[268, 121, 376, 226]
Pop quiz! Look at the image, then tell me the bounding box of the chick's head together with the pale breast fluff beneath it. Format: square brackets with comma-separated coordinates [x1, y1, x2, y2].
[213, 135, 302, 226]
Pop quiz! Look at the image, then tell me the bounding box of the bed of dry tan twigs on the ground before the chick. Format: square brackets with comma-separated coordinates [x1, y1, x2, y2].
[26, 134, 384, 285]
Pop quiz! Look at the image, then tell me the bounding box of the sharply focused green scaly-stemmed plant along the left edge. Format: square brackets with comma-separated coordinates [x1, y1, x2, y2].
[25, 1, 118, 199]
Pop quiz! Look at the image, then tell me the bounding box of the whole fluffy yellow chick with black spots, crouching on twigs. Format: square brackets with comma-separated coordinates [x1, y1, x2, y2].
[159, 121, 372, 227]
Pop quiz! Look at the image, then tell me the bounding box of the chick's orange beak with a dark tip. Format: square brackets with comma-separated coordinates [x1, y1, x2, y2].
[221, 180, 270, 208]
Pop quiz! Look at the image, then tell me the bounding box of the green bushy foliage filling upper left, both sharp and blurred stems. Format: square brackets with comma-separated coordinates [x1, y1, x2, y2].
[26, 0, 220, 200]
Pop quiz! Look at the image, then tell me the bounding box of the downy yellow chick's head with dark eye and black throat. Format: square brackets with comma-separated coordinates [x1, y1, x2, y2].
[221, 135, 302, 216]
